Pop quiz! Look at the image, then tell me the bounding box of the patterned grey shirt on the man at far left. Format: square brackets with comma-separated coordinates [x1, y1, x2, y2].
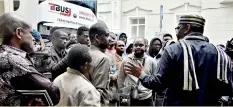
[0, 45, 32, 106]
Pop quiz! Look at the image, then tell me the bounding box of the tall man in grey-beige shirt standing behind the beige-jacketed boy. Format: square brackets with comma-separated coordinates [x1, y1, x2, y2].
[85, 21, 110, 106]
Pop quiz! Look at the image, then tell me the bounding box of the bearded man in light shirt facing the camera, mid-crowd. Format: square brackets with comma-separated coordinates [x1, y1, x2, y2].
[117, 38, 156, 106]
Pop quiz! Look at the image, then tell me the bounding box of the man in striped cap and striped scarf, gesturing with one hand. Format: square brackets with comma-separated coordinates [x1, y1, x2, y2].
[125, 15, 232, 106]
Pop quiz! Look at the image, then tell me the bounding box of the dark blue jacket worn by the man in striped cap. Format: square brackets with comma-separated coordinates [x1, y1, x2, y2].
[139, 33, 232, 106]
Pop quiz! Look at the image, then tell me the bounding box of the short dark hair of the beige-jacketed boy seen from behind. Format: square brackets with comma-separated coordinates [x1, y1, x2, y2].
[67, 44, 92, 70]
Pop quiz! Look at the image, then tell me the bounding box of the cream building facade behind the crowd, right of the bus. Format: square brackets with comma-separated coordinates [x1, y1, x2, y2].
[98, 0, 233, 45]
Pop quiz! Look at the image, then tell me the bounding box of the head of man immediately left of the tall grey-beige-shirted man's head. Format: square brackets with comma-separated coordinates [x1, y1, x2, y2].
[77, 26, 90, 46]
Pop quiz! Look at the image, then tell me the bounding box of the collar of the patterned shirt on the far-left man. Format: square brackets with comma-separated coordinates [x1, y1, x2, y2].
[2, 45, 27, 58]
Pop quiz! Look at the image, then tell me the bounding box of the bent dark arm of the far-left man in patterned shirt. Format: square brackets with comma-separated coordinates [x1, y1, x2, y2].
[11, 65, 60, 105]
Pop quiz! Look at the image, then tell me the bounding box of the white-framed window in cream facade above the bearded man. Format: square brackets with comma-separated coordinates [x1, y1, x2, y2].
[130, 17, 146, 38]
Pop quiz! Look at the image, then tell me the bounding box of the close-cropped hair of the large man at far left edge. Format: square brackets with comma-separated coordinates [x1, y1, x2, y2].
[0, 13, 30, 44]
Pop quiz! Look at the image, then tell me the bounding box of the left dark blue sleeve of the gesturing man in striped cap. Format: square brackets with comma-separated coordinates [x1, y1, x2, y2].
[139, 49, 172, 90]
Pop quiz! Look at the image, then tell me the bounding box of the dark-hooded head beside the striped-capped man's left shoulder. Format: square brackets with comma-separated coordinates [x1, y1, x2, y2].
[149, 38, 162, 58]
